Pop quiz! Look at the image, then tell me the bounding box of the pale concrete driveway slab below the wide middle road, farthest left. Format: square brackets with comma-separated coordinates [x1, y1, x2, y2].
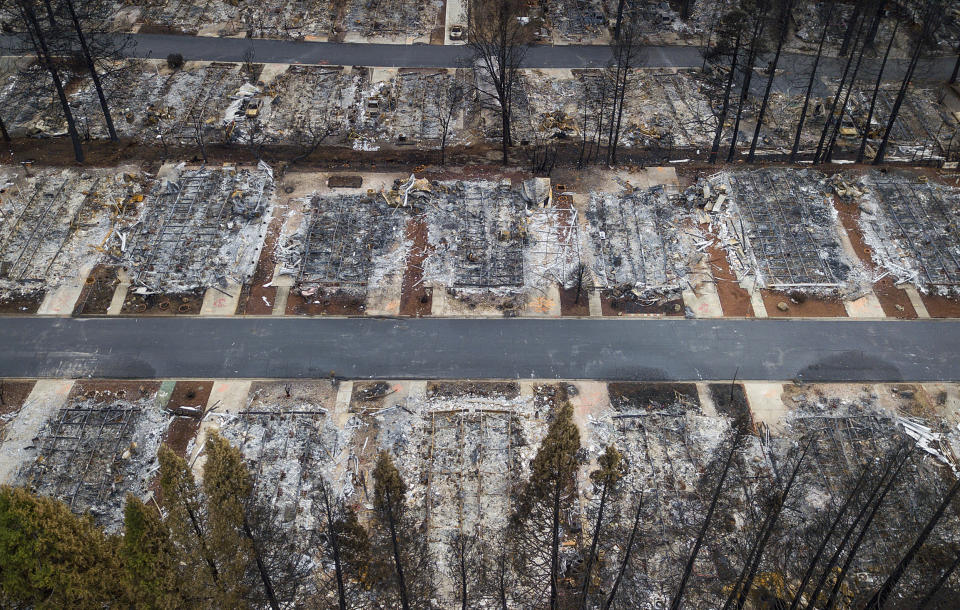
[0, 379, 73, 485]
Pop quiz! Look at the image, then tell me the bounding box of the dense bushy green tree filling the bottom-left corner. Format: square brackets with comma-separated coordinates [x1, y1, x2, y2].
[0, 486, 121, 609]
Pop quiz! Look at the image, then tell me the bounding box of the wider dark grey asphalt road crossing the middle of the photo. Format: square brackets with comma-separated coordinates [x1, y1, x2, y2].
[0, 317, 960, 381]
